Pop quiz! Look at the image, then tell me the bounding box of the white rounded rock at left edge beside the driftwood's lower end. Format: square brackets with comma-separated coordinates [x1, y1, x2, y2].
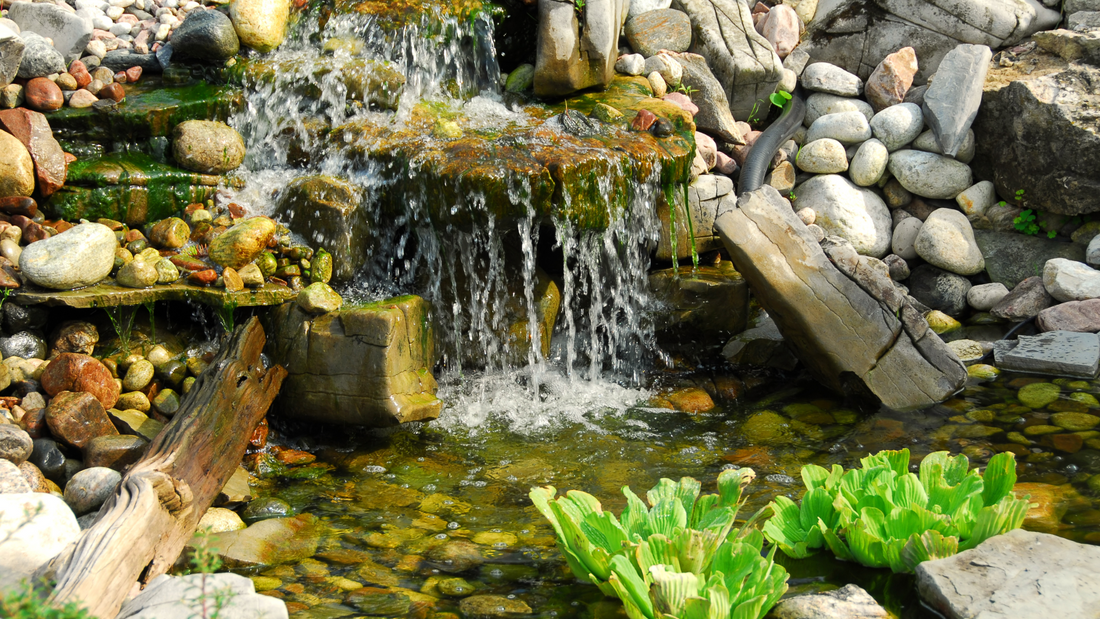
[0, 493, 80, 592]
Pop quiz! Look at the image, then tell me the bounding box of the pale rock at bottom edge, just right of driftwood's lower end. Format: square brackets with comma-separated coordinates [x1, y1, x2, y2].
[117, 573, 287, 619]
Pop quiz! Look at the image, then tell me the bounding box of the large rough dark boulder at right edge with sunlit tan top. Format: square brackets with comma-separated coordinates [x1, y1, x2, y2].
[974, 52, 1100, 215]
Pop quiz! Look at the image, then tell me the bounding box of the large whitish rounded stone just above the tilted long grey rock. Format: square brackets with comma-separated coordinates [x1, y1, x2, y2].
[796, 174, 892, 257]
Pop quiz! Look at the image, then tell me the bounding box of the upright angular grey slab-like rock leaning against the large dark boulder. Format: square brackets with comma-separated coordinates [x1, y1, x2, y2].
[923, 44, 993, 157]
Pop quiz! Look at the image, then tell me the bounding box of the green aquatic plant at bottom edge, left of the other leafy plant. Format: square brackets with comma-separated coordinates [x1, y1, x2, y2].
[530, 468, 788, 619]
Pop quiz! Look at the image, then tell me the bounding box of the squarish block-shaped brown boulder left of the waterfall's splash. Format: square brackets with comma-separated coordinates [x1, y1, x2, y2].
[268, 297, 442, 427]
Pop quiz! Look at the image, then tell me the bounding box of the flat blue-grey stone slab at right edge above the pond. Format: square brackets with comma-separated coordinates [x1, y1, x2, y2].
[993, 331, 1100, 378]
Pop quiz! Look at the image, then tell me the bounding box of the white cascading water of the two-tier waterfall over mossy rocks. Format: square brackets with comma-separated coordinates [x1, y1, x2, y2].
[223, 2, 663, 430]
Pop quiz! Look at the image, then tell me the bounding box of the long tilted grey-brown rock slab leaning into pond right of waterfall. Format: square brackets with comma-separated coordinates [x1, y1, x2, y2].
[715, 186, 966, 410]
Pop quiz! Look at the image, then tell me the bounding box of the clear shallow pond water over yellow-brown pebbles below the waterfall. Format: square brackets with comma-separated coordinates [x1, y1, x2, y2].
[227, 354, 1100, 618]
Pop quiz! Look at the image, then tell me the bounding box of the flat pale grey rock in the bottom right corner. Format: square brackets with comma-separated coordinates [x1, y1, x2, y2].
[916, 529, 1100, 619]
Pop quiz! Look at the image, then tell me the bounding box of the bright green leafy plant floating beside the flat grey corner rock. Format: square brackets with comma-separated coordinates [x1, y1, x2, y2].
[763, 450, 1029, 573]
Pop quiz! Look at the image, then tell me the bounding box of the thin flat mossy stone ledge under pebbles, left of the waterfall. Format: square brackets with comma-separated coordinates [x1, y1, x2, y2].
[10, 279, 298, 309]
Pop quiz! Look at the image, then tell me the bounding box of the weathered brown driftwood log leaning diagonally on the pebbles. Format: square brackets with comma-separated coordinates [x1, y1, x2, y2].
[40, 318, 286, 619]
